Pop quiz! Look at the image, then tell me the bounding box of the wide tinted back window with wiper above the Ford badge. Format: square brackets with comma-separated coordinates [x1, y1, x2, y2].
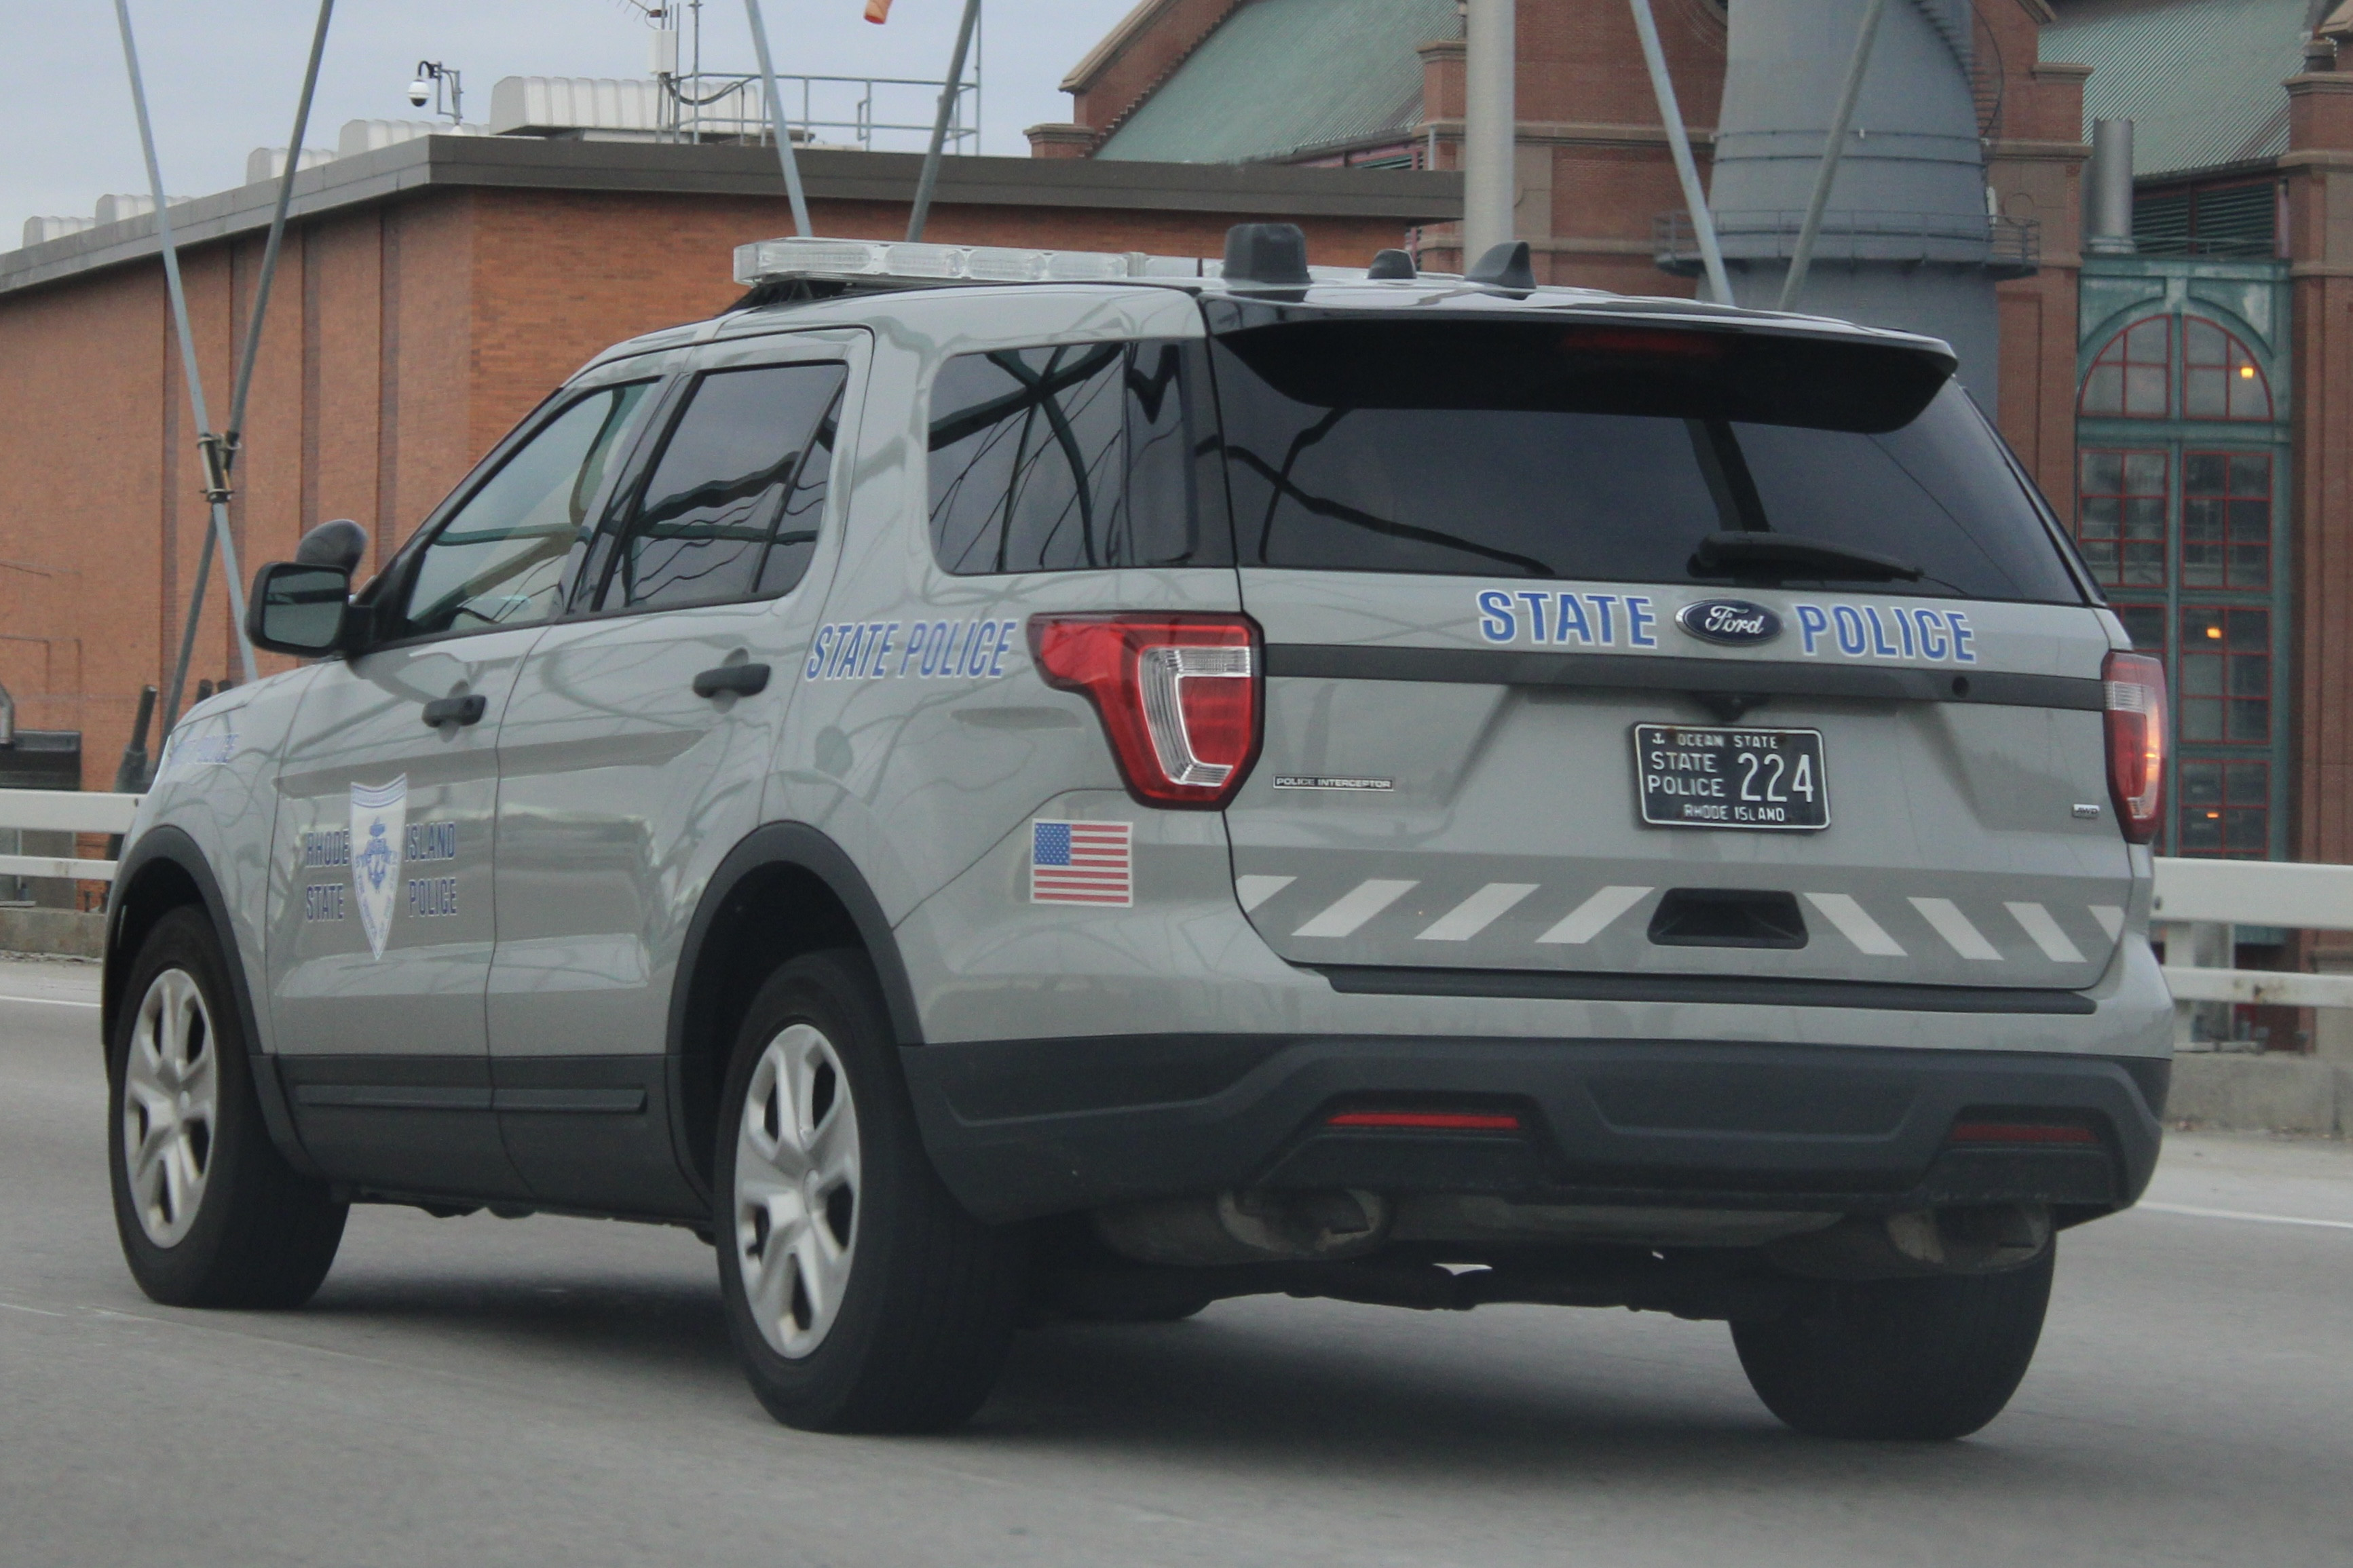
[1216, 320, 2082, 604]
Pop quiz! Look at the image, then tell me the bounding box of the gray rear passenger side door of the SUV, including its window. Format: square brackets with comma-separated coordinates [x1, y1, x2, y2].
[489, 332, 868, 1210]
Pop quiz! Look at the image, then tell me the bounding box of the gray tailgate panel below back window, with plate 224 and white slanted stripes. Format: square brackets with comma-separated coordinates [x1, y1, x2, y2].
[1226, 571, 2132, 987]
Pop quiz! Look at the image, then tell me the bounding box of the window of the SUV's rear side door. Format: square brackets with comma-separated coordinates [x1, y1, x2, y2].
[590, 364, 847, 609]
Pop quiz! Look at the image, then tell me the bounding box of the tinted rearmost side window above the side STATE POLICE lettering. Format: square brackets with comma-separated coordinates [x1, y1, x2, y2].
[932, 341, 1230, 573]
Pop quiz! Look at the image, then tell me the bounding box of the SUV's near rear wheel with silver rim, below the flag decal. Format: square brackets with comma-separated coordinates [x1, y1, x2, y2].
[713, 950, 1023, 1432]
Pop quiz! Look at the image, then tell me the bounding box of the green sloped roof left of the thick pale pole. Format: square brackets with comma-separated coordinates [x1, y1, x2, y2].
[1097, 0, 1461, 162]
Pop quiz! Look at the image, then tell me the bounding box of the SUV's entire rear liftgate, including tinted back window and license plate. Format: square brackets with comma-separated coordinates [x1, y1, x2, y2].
[1216, 318, 2132, 995]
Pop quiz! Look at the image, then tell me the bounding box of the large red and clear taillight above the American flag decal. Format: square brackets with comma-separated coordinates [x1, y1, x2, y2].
[1031, 616, 1261, 809]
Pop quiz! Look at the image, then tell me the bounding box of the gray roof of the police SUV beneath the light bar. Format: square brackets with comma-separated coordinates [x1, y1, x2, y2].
[573, 240, 1953, 385]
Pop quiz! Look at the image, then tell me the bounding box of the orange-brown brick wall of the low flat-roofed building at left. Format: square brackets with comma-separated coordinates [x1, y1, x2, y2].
[0, 188, 1402, 788]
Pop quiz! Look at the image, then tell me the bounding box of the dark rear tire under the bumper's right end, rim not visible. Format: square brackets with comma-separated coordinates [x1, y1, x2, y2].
[1732, 1244, 2059, 1441]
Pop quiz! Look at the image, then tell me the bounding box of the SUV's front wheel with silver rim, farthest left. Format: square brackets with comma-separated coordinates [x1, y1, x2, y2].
[106, 907, 348, 1307]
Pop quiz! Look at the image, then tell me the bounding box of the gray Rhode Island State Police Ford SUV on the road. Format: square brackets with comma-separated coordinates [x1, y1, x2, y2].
[106, 226, 2170, 1436]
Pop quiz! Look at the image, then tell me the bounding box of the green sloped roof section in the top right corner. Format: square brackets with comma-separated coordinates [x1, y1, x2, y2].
[2042, 0, 2311, 178]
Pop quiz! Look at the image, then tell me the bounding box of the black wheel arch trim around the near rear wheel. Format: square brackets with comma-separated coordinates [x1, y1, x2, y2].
[666, 823, 922, 1192]
